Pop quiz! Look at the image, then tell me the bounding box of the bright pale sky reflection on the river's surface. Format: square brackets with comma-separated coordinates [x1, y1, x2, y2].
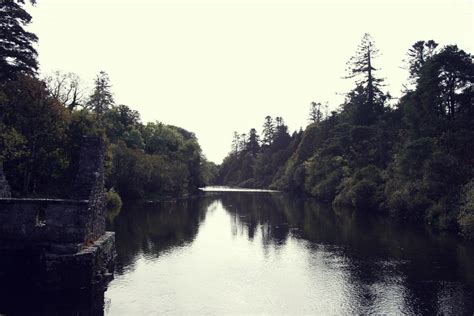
[106, 201, 416, 315]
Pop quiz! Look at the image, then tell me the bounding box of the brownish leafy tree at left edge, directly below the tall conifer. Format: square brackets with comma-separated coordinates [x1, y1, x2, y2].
[2, 76, 70, 195]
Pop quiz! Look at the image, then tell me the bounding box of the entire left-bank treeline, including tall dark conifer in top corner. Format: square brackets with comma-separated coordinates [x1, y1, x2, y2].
[0, 1, 215, 198]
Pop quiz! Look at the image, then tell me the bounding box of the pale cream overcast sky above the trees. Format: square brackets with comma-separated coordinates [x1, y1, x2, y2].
[28, 0, 474, 163]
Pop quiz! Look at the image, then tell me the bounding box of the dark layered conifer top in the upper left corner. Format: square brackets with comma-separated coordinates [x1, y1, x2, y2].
[0, 0, 38, 82]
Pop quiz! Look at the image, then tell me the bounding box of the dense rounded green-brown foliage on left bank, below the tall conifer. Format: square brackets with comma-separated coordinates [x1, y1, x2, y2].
[0, 75, 215, 198]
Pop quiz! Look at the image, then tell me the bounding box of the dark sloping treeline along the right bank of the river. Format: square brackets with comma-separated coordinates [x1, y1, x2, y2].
[219, 34, 474, 235]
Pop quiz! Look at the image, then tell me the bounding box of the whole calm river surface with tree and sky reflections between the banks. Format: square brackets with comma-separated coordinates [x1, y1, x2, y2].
[103, 192, 474, 315]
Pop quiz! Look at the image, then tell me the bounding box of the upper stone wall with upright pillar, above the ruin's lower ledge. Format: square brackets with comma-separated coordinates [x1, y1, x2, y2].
[0, 137, 105, 251]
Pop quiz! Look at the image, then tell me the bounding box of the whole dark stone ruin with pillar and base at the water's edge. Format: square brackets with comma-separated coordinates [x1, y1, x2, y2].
[0, 137, 116, 288]
